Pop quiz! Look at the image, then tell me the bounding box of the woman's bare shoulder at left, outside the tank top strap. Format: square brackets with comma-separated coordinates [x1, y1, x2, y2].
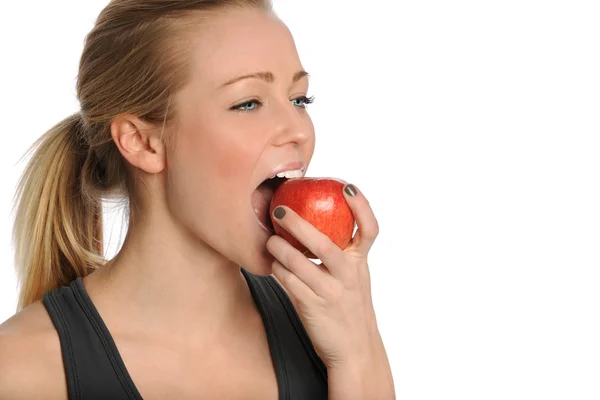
[0, 301, 67, 400]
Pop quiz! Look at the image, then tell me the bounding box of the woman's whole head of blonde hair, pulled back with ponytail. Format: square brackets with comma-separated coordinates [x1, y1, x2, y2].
[13, 0, 272, 310]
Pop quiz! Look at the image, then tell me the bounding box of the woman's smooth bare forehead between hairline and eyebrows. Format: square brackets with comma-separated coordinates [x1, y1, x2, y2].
[186, 10, 301, 85]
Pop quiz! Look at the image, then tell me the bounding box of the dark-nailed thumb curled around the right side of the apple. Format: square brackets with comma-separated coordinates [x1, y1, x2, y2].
[344, 184, 379, 255]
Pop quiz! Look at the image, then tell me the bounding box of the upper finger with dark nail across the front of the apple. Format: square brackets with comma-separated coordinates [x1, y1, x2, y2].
[273, 206, 344, 276]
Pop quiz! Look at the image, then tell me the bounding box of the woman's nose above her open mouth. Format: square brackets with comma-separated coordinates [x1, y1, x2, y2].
[270, 102, 314, 146]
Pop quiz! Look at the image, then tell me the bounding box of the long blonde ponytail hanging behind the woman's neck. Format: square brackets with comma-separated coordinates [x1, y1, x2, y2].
[13, 113, 104, 311]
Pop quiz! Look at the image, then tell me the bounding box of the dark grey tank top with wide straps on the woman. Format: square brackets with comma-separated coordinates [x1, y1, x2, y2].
[42, 268, 327, 400]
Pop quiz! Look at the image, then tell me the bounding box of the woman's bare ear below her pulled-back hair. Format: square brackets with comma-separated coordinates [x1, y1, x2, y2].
[110, 114, 166, 174]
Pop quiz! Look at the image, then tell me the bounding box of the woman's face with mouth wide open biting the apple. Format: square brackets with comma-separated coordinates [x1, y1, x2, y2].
[167, 10, 315, 275]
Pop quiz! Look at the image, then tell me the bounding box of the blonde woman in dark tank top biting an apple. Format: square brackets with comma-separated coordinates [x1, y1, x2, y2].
[0, 0, 394, 400]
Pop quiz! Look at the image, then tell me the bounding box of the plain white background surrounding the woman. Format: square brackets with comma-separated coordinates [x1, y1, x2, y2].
[0, 0, 600, 400]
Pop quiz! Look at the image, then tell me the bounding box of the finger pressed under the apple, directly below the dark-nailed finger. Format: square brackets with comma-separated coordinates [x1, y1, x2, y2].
[267, 235, 334, 296]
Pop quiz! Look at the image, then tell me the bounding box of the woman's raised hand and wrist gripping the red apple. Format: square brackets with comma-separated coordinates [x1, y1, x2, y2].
[267, 185, 394, 399]
